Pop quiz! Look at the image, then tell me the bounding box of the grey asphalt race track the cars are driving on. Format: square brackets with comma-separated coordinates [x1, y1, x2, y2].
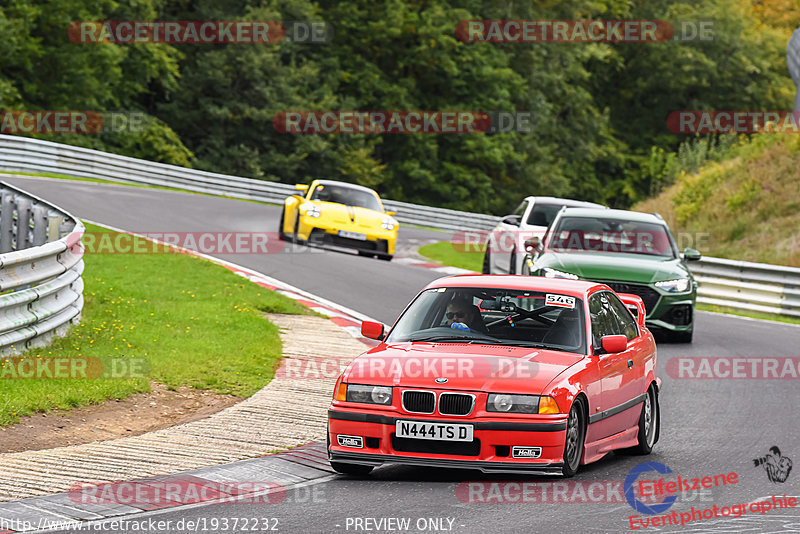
[10, 178, 800, 533]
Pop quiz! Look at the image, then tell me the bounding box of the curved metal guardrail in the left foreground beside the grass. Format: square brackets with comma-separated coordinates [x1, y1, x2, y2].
[0, 182, 84, 355]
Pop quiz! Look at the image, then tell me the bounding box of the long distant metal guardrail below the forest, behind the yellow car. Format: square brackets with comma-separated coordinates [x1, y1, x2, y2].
[0, 135, 500, 230]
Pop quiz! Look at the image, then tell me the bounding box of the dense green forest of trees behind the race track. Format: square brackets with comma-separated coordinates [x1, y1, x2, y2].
[0, 0, 800, 214]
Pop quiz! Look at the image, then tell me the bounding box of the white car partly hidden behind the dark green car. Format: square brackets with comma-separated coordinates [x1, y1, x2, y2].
[483, 197, 605, 274]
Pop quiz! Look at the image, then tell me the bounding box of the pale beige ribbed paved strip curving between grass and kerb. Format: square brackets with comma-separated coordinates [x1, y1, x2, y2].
[0, 314, 368, 501]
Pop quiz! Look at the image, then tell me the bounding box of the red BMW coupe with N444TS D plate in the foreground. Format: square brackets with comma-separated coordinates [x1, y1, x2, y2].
[328, 275, 661, 477]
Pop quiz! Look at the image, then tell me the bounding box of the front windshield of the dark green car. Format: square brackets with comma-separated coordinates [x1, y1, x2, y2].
[545, 217, 676, 258]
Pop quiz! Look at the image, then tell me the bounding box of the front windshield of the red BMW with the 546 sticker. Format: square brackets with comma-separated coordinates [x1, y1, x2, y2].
[386, 287, 586, 354]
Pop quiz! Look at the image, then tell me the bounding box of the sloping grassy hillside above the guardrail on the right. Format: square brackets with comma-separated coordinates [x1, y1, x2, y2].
[632, 134, 800, 267]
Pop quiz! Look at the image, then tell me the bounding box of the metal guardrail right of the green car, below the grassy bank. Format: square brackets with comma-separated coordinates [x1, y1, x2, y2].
[687, 258, 800, 318]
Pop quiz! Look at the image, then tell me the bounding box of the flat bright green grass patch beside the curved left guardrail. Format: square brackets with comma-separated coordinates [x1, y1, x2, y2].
[0, 224, 313, 426]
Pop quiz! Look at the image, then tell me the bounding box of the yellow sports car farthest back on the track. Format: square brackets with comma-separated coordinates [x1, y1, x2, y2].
[278, 180, 398, 260]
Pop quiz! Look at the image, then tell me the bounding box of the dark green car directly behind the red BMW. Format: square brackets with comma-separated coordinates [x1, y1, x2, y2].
[522, 208, 700, 343]
